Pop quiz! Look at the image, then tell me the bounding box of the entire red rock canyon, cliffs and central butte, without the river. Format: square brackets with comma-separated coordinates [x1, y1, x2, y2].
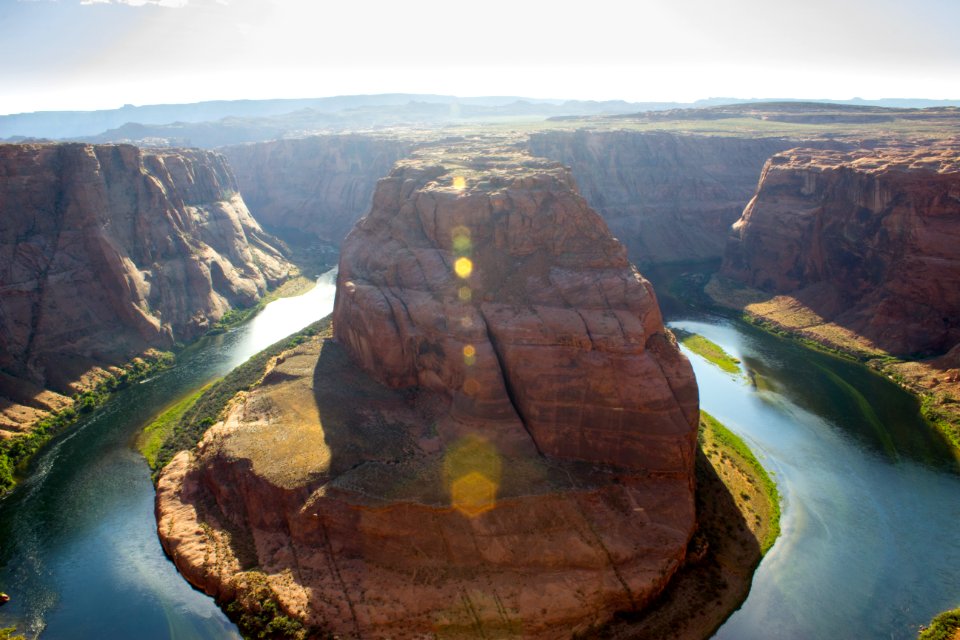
[0, 105, 960, 637]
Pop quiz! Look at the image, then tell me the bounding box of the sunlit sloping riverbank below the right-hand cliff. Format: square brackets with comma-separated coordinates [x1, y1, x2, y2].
[700, 274, 960, 459]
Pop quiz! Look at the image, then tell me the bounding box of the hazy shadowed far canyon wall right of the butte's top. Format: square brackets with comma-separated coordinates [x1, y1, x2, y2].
[529, 130, 797, 265]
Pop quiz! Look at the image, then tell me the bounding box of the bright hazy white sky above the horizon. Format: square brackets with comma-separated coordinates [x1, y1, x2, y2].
[0, 0, 960, 113]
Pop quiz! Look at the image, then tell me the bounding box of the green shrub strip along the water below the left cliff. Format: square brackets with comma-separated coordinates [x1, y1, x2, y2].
[0, 351, 174, 497]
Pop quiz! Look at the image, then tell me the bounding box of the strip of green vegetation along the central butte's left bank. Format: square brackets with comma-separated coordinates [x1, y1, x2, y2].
[151, 318, 330, 473]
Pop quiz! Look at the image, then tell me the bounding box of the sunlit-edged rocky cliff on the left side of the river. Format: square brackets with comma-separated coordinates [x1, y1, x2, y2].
[0, 144, 290, 432]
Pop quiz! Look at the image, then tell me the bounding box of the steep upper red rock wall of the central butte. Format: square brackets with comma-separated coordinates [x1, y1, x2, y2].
[334, 152, 698, 474]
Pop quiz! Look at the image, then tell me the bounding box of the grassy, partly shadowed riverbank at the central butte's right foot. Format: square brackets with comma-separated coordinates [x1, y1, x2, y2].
[596, 412, 780, 640]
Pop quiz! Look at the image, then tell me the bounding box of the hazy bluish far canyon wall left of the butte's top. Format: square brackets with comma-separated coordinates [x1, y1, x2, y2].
[220, 134, 412, 244]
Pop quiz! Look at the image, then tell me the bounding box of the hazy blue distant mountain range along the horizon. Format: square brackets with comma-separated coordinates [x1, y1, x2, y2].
[0, 93, 960, 147]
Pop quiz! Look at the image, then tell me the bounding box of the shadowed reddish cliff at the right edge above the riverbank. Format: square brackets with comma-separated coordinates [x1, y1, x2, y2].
[721, 142, 960, 355]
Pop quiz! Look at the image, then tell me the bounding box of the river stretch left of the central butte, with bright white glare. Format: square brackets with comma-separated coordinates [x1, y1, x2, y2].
[0, 272, 336, 640]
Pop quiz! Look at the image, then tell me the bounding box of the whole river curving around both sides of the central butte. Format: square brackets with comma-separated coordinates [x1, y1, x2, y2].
[0, 264, 960, 640]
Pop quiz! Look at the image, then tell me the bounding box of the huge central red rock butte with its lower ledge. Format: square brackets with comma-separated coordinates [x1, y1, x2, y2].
[157, 143, 698, 638]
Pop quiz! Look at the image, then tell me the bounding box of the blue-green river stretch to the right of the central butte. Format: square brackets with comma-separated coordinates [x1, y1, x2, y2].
[671, 316, 960, 640]
